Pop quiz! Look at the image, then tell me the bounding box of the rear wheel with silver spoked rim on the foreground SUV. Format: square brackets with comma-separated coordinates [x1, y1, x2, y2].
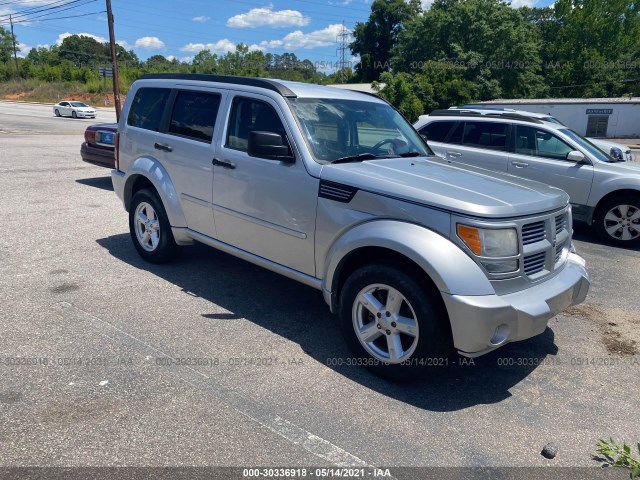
[129, 189, 179, 263]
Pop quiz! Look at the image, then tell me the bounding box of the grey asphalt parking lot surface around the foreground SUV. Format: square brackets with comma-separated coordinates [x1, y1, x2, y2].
[0, 103, 640, 478]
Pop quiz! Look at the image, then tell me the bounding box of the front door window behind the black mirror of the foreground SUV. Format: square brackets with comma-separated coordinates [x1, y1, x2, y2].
[226, 97, 287, 152]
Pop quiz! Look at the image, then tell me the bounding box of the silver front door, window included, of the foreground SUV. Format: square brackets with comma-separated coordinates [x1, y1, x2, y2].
[213, 92, 319, 276]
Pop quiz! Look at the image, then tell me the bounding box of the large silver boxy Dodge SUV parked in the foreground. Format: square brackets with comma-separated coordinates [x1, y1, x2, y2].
[112, 74, 590, 379]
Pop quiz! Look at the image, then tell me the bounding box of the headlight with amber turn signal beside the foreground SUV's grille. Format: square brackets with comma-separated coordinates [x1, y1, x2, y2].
[457, 224, 519, 273]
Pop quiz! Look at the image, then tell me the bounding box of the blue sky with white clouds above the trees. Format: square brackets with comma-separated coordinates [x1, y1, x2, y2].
[0, 0, 550, 70]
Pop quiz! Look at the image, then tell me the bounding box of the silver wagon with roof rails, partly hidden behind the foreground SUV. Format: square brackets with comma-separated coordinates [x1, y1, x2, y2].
[414, 109, 640, 247]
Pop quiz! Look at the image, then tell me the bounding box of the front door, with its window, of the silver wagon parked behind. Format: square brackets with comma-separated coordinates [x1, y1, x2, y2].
[509, 125, 593, 205]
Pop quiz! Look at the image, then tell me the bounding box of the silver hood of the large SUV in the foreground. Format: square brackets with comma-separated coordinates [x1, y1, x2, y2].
[320, 157, 569, 218]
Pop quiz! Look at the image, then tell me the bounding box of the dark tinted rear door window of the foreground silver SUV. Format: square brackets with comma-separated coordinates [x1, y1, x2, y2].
[169, 91, 220, 142]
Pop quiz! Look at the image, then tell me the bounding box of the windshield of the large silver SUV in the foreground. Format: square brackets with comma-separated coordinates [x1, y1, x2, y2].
[290, 98, 433, 163]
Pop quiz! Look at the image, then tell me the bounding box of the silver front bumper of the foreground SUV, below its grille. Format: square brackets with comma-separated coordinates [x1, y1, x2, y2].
[442, 253, 591, 357]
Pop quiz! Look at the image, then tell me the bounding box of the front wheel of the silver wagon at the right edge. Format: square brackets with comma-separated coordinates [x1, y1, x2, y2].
[594, 194, 640, 247]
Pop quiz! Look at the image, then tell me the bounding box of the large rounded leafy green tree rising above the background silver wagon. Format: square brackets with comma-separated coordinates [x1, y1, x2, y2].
[393, 0, 545, 99]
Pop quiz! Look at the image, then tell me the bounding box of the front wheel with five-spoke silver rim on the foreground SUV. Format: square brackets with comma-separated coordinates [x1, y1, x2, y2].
[339, 265, 453, 381]
